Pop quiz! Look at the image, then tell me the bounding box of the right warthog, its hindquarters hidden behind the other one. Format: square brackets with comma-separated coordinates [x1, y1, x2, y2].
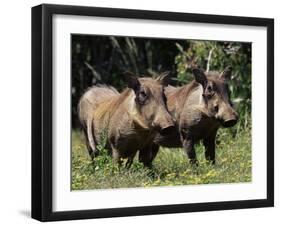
[139, 67, 238, 166]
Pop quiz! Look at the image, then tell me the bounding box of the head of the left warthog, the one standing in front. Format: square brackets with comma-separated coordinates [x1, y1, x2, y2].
[126, 73, 174, 133]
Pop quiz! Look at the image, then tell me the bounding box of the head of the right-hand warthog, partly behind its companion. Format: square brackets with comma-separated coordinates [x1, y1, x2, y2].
[192, 67, 238, 127]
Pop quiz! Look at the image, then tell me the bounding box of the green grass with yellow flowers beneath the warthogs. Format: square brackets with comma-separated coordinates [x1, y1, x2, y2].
[72, 124, 252, 190]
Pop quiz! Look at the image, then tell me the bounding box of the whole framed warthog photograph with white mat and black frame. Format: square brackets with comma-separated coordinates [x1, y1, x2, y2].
[32, 4, 274, 221]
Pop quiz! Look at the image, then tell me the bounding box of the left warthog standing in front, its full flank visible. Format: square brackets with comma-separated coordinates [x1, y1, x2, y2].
[78, 74, 174, 167]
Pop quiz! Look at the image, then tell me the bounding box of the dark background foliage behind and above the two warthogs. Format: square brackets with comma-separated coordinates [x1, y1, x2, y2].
[71, 35, 251, 128]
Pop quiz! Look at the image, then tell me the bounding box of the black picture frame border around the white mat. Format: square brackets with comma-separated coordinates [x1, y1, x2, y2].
[32, 4, 274, 221]
